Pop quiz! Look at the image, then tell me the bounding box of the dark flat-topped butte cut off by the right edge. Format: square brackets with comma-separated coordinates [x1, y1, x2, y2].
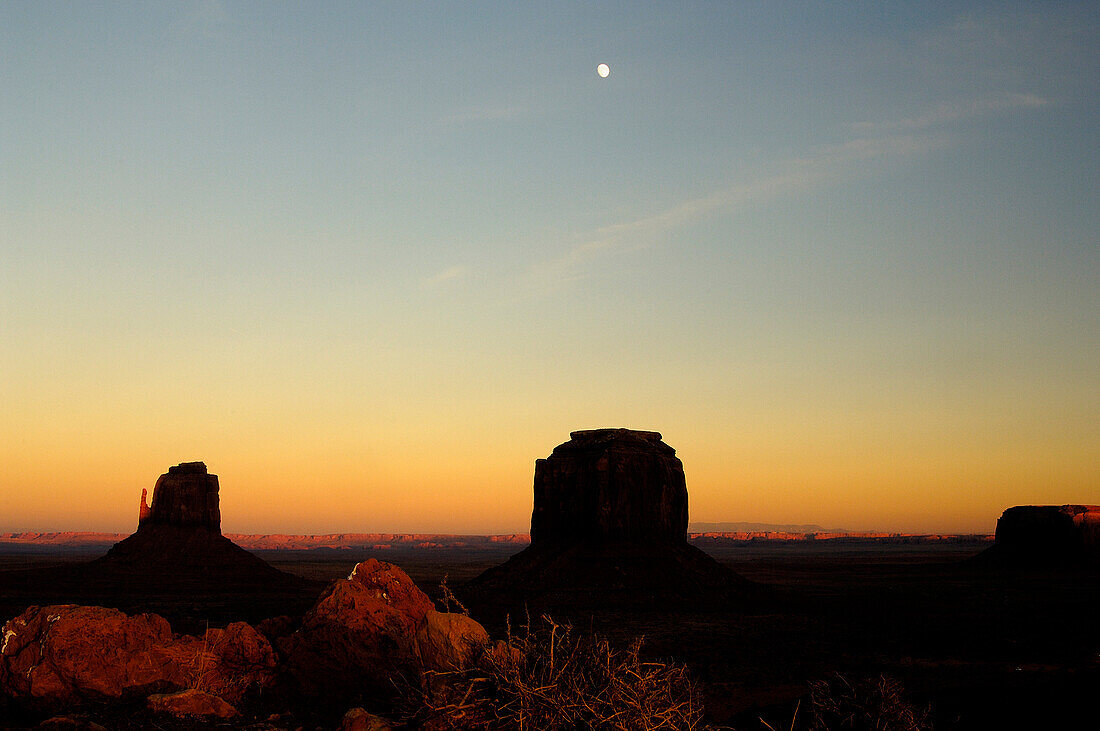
[978, 505, 1100, 567]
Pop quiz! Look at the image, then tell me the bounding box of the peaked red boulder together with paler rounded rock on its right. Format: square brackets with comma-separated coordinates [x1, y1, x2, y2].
[279, 558, 488, 697]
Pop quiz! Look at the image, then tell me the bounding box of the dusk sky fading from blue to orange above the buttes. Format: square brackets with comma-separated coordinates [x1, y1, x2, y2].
[0, 1, 1100, 533]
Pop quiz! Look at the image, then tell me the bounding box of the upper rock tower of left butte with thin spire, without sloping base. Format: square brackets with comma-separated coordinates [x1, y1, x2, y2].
[138, 462, 221, 533]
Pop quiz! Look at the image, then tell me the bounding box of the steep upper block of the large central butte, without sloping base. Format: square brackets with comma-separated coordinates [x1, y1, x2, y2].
[531, 429, 688, 545]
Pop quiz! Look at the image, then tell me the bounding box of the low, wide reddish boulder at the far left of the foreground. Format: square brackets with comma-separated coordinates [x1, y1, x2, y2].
[0, 605, 275, 708]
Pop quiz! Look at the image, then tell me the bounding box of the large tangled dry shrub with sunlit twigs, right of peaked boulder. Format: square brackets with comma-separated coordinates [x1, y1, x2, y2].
[406, 616, 703, 731]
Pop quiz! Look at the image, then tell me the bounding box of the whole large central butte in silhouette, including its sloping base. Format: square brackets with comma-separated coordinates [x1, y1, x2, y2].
[464, 429, 747, 606]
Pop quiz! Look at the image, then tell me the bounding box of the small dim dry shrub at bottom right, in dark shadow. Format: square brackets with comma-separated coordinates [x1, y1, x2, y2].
[810, 675, 932, 731]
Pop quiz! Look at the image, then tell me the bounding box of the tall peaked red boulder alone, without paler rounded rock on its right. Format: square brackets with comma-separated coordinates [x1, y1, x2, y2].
[279, 558, 433, 697]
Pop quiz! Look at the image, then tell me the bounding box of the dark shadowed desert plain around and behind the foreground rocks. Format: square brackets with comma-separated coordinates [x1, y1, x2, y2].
[0, 540, 1100, 729]
